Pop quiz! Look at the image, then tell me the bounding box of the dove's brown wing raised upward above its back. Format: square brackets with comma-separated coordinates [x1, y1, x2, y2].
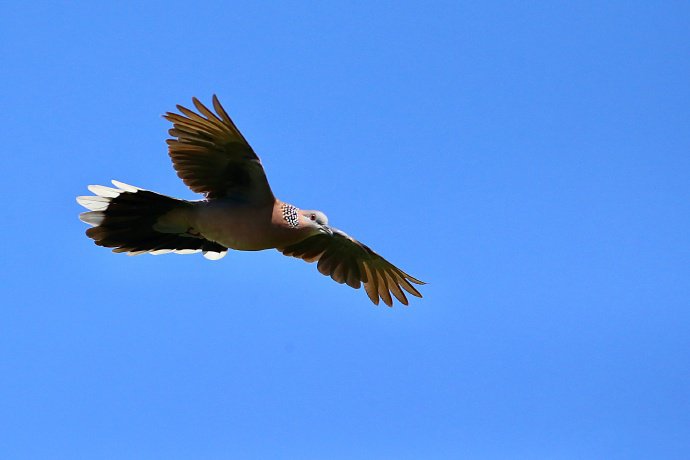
[164, 95, 275, 205]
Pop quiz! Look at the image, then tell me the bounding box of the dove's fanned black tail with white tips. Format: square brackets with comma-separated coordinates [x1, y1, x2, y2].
[77, 181, 228, 260]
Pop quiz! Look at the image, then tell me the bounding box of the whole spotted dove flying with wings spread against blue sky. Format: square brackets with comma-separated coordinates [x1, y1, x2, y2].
[77, 95, 426, 307]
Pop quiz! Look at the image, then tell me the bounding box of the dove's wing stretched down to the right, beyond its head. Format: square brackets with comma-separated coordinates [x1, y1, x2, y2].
[279, 227, 426, 307]
